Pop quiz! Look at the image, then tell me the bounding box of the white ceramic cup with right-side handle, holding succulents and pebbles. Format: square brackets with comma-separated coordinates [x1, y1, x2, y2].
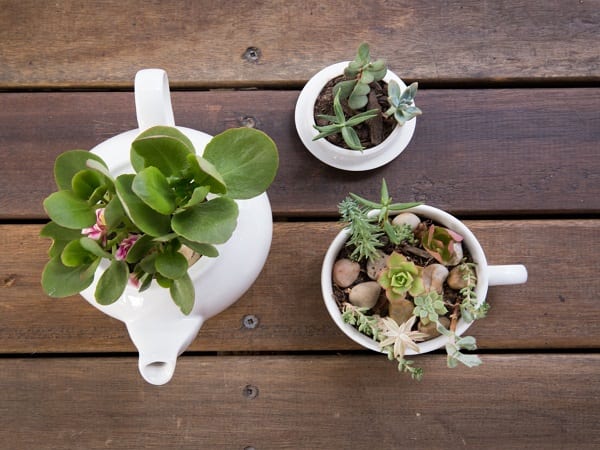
[321, 205, 527, 355]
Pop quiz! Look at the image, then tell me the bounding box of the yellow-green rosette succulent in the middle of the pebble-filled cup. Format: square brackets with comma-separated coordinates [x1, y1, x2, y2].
[377, 252, 425, 301]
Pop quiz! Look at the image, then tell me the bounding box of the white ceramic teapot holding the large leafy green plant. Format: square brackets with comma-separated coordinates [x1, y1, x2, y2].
[81, 69, 273, 385]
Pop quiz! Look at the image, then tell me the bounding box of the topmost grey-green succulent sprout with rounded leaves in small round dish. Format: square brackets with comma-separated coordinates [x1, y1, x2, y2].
[333, 43, 387, 111]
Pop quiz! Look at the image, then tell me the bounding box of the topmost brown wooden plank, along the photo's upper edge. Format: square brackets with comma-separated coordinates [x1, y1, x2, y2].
[0, 0, 600, 89]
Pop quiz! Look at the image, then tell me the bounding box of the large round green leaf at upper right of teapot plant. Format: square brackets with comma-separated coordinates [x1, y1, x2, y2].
[203, 128, 279, 199]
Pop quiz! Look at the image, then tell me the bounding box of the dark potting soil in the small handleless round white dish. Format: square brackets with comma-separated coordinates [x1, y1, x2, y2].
[314, 75, 396, 151]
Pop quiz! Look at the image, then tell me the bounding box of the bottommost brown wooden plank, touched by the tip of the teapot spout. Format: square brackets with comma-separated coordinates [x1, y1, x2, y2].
[0, 354, 600, 450]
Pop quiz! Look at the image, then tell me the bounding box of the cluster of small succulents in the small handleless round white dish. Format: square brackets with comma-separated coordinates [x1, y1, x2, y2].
[313, 43, 422, 151]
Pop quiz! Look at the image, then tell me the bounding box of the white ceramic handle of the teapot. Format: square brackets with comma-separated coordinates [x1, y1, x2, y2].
[134, 69, 175, 131]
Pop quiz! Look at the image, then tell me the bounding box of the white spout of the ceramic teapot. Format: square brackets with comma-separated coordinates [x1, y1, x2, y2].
[127, 316, 204, 385]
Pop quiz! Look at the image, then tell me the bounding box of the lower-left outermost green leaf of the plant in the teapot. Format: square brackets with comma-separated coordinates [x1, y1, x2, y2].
[42, 256, 100, 297]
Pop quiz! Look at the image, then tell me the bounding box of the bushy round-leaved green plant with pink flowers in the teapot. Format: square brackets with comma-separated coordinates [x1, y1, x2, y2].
[41, 126, 279, 315]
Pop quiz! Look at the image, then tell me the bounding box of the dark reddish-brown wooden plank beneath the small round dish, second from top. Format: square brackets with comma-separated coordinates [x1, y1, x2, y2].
[0, 88, 600, 220]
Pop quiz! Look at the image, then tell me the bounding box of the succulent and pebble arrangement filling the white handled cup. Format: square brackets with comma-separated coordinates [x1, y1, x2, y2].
[333, 180, 488, 380]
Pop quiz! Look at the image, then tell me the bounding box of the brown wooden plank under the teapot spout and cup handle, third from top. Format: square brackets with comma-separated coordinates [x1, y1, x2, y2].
[0, 220, 600, 354]
